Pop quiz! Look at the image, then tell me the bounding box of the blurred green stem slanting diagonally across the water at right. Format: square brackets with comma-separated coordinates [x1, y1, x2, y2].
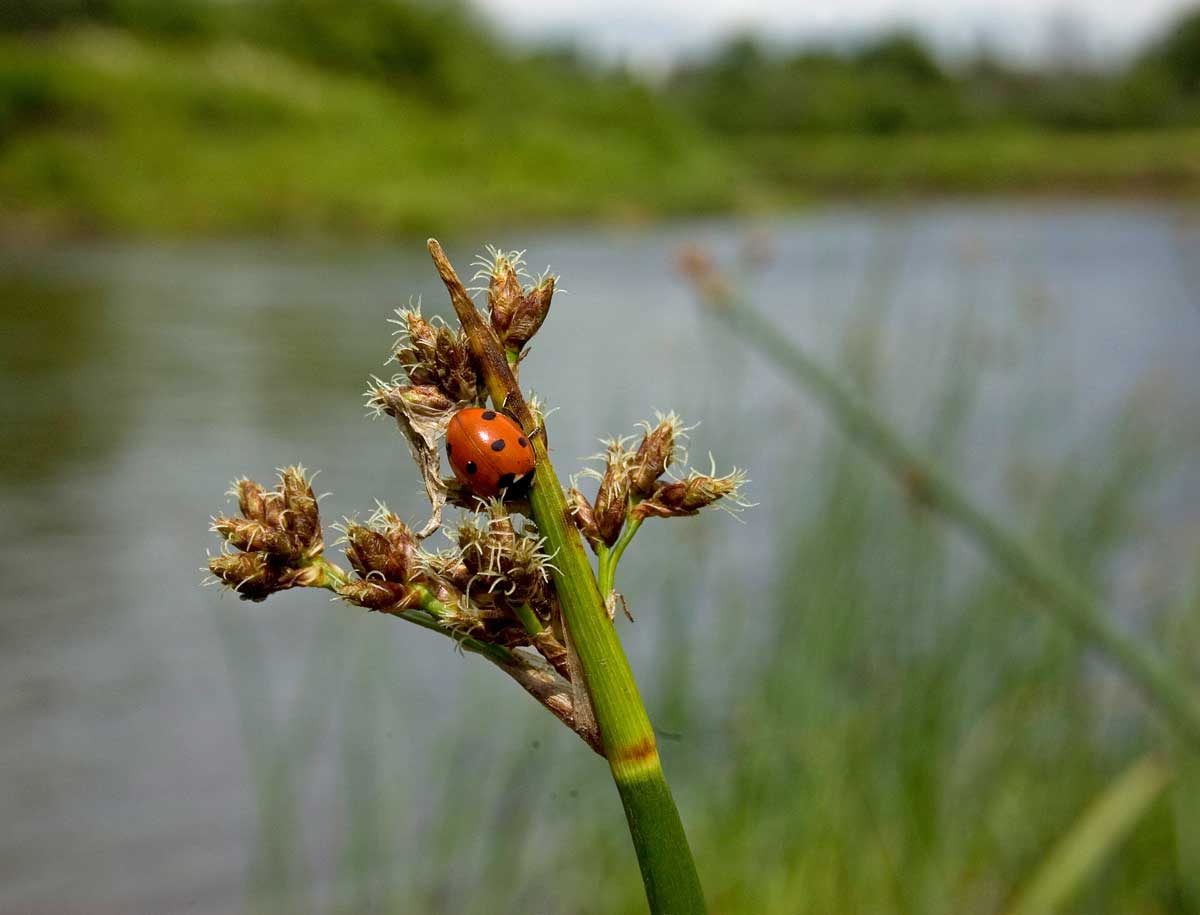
[712, 294, 1200, 749]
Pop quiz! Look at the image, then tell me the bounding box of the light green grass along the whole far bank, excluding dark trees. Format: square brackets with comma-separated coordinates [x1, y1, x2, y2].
[0, 25, 1200, 237]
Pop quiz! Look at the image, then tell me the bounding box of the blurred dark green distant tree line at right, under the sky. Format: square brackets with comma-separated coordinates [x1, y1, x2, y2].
[667, 16, 1200, 134]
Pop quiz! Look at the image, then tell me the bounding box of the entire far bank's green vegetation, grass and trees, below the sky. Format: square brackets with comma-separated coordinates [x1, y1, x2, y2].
[7, 0, 1200, 235]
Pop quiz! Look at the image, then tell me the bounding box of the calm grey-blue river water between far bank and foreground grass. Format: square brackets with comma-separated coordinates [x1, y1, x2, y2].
[0, 203, 1200, 911]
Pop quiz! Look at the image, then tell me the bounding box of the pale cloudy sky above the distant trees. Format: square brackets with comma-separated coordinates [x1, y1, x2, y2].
[474, 0, 1196, 70]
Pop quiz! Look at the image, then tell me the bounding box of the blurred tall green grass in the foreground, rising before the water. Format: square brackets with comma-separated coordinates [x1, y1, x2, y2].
[220, 301, 1200, 915]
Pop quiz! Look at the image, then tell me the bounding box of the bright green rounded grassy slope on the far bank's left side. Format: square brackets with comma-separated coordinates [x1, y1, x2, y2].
[0, 28, 732, 234]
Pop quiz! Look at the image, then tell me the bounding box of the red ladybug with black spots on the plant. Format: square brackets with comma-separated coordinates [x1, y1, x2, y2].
[446, 407, 534, 498]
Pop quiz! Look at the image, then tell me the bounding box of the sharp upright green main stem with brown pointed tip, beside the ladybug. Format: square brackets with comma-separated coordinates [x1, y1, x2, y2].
[428, 239, 706, 915]
